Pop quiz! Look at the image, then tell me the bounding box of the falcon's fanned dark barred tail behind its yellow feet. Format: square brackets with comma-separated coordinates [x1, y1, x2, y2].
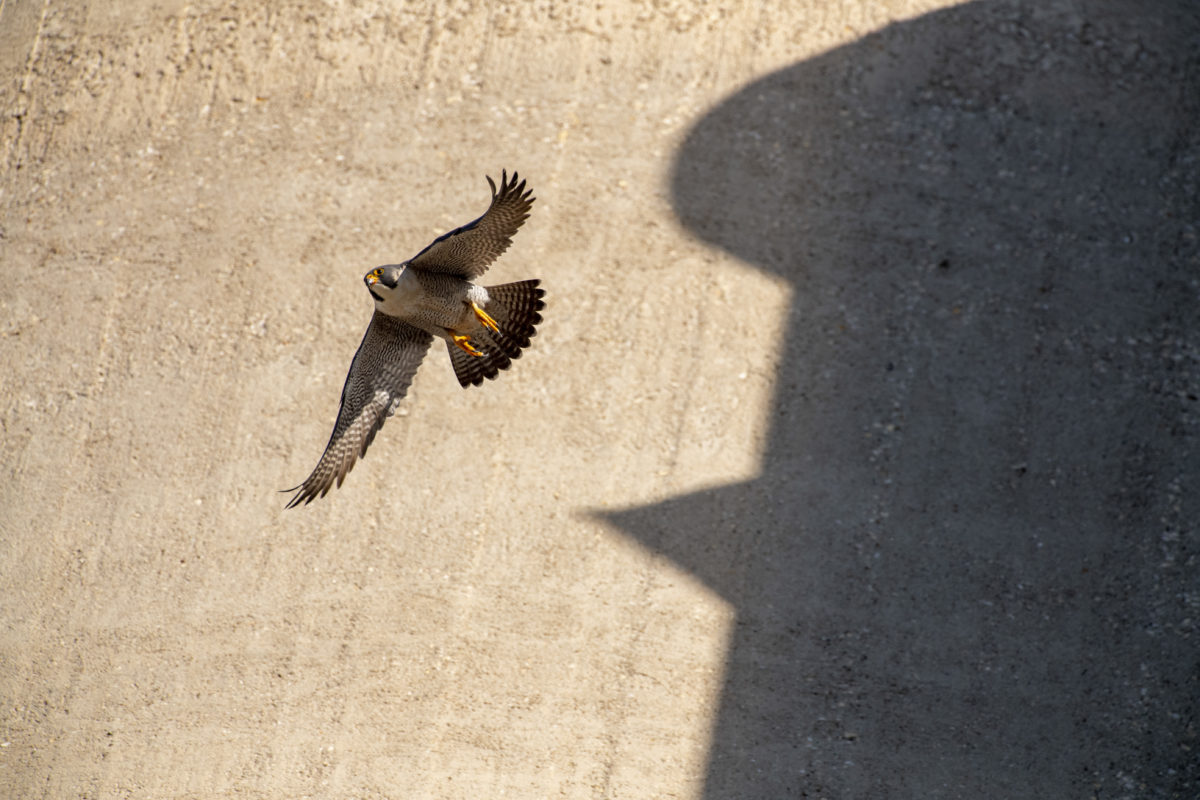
[446, 278, 546, 386]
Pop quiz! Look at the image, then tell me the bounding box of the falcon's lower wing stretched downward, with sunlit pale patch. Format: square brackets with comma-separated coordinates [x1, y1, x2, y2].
[284, 311, 433, 509]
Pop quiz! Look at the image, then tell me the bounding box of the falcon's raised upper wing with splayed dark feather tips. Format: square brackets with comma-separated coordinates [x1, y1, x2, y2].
[408, 172, 535, 281]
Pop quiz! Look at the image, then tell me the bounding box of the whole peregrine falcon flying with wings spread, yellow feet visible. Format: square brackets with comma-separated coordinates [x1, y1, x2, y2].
[284, 170, 545, 509]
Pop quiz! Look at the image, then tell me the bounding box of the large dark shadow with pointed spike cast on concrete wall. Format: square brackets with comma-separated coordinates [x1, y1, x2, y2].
[606, 0, 1200, 800]
